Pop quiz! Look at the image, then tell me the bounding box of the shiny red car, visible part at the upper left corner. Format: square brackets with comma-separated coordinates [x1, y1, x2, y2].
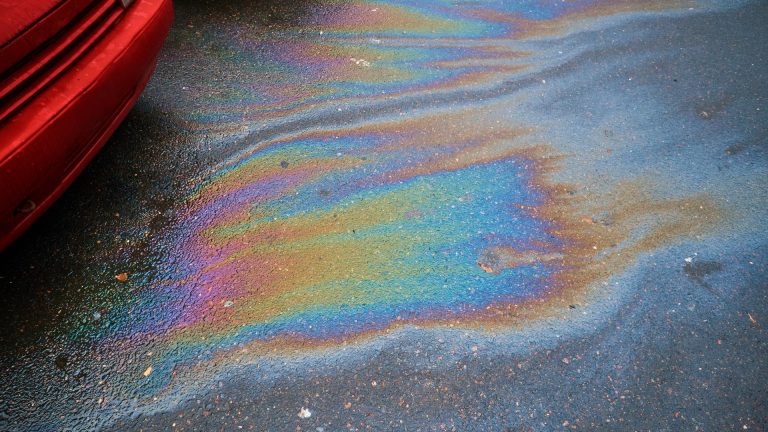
[0, 0, 173, 251]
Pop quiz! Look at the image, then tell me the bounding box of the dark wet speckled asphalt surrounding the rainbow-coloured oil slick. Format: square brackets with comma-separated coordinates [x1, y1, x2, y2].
[0, 0, 768, 431]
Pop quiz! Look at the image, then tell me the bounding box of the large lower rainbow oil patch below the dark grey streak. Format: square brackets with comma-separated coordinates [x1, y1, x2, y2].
[103, 105, 724, 404]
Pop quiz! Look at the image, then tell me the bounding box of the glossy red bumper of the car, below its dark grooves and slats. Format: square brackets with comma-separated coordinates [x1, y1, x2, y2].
[0, 0, 173, 251]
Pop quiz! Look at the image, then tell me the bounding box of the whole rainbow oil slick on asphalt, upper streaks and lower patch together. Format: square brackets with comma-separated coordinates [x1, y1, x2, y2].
[1, 0, 726, 423]
